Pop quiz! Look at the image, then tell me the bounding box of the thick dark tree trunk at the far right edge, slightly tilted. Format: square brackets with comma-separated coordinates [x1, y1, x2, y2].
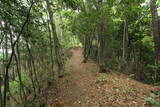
[150, 0, 160, 63]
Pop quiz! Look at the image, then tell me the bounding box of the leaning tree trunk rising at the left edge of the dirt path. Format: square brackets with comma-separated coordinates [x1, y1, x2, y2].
[45, 0, 64, 73]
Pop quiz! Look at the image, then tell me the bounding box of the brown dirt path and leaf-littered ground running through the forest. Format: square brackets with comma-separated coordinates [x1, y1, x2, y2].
[45, 48, 157, 107]
